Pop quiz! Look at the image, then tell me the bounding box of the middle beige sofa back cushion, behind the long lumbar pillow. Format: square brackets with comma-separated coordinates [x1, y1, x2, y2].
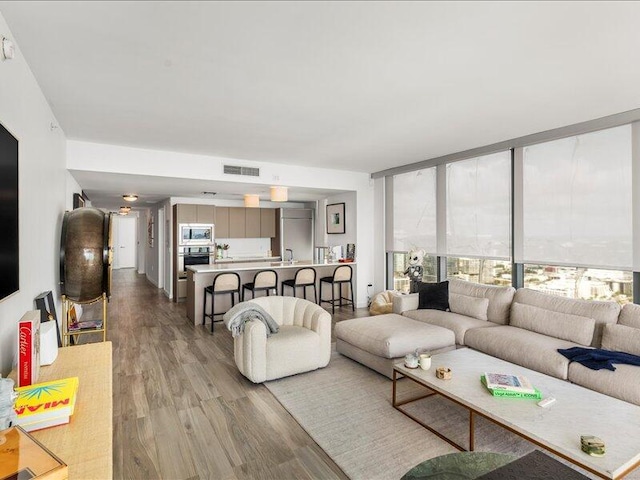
[513, 288, 620, 347]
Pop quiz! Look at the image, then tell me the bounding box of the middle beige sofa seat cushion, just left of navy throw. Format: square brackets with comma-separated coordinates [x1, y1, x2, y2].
[464, 325, 576, 380]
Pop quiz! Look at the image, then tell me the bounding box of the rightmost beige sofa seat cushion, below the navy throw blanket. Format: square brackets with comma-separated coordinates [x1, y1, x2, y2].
[569, 362, 640, 405]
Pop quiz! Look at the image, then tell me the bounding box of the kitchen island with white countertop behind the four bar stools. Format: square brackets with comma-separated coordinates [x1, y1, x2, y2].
[187, 260, 357, 325]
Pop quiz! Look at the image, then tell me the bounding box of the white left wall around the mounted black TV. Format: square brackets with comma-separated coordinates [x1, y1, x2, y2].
[0, 14, 68, 375]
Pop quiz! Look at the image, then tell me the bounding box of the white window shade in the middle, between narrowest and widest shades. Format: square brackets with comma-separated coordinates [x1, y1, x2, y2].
[441, 151, 511, 260]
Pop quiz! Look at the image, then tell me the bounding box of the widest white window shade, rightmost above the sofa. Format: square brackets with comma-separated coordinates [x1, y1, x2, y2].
[516, 125, 633, 270]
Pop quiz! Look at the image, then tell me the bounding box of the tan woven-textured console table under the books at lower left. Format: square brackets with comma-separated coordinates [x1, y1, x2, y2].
[11, 342, 113, 480]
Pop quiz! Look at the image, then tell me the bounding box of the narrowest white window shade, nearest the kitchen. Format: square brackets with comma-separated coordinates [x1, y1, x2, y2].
[393, 167, 436, 254]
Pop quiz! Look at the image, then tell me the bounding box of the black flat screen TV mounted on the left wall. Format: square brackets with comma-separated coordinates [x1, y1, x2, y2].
[0, 124, 20, 300]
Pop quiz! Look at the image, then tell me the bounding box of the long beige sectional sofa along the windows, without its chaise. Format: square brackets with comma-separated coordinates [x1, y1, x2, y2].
[394, 279, 640, 405]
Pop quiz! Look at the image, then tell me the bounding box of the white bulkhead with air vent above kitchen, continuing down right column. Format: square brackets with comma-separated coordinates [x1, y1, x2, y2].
[67, 140, 382, 306]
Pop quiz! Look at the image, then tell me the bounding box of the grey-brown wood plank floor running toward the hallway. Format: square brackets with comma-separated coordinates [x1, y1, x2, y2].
[100, 270, 368, 480]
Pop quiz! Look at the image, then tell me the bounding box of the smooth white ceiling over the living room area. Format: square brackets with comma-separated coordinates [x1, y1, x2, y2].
[0, 1, 640, 204]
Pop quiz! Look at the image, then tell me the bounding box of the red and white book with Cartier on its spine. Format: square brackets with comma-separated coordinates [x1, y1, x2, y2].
[17, 310, 40, 387]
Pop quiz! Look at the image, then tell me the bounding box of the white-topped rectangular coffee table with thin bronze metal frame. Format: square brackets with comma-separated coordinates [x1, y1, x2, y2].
[393, 348, 640, 479]
